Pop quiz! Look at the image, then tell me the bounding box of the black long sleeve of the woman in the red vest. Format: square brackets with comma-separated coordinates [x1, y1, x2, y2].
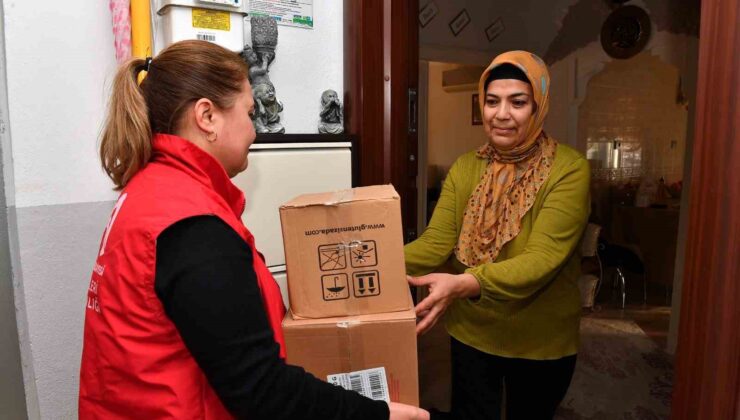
[155, 216, 389, 420]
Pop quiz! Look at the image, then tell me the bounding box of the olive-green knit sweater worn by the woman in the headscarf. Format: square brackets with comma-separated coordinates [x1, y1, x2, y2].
[404, 144, 590, 360]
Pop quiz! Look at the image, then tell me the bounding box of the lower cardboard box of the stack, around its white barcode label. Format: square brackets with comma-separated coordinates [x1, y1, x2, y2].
[283, 309, 419, 406]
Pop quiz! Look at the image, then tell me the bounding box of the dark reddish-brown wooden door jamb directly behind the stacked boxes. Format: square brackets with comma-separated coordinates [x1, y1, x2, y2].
[344, 0, 419, 242]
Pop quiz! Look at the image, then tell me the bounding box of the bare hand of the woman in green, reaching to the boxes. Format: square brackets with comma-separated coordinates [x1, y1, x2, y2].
[406, 273, 480, 335]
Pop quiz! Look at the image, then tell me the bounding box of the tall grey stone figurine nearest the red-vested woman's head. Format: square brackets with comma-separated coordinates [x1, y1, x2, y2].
[241, 16, 285, 133]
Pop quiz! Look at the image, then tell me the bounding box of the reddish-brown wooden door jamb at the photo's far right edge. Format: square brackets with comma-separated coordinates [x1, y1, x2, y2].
[672, 0, 740, 420]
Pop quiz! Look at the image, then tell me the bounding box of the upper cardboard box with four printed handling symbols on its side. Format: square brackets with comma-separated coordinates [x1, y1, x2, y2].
[280, 185, 413, 318]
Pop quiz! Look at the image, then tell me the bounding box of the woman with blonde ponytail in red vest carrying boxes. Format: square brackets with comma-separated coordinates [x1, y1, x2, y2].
[79, 41, 428, 419]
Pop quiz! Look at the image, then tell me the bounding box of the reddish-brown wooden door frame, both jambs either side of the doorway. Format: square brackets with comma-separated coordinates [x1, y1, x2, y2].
[344, 0, 740, 420]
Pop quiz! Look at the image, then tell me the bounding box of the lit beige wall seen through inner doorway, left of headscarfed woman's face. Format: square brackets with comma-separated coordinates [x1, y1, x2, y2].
[427, 62, 486, 186]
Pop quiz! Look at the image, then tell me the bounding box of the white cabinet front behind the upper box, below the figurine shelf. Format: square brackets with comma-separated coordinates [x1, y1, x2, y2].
[232, 142, 352, 267]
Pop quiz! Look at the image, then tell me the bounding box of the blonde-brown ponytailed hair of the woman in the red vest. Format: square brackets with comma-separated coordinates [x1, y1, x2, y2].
[100, 41, 248, 190]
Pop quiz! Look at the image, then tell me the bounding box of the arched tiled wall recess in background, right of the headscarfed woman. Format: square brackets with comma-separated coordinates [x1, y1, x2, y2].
[577, 53, 688, 184]
